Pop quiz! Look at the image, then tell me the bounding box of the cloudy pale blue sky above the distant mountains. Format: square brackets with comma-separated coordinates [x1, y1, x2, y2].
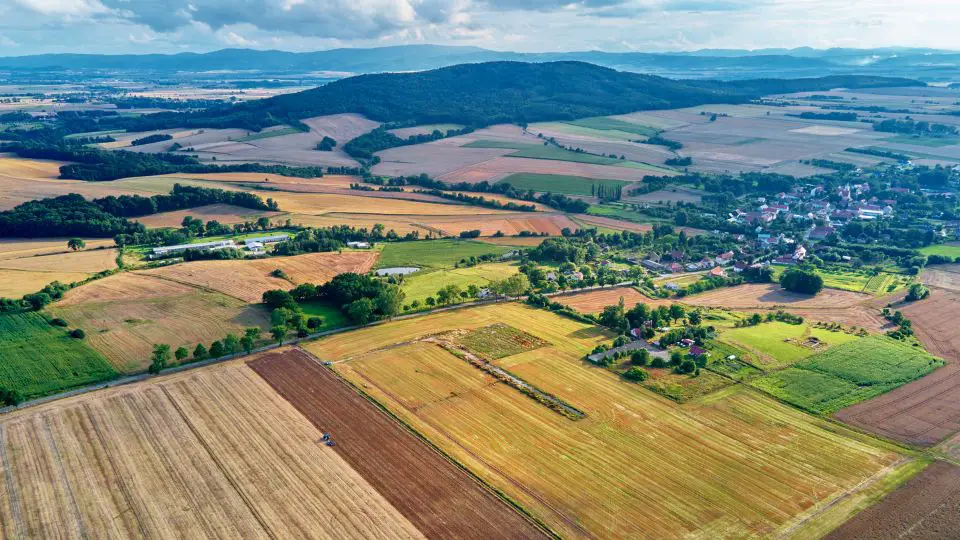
[0, 0, 960, 56]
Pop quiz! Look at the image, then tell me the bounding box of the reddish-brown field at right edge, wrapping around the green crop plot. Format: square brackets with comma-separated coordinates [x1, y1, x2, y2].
[834, 289, 960, 446]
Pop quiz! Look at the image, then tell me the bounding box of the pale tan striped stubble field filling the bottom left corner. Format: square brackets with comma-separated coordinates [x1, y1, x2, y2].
[0, 362, 422, 539]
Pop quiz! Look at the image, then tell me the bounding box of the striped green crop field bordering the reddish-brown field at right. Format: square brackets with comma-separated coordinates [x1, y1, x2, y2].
[750, 336, 943, 414]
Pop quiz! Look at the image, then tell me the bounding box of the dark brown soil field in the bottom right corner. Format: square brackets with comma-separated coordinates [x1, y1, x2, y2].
[826, 461, 960, 540]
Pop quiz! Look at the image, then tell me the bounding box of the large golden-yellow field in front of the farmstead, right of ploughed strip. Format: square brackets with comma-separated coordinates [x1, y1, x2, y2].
[307, 305, 895, 537]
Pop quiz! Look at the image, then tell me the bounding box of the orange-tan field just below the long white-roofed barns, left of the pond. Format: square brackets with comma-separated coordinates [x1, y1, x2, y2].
[138, 251, 379, 303]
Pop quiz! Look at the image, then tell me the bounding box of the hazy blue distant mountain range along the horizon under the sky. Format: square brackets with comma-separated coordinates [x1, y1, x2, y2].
[0, 45, 960, 81]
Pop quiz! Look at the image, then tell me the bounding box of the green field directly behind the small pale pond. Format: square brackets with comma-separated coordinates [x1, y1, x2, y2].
[376, 239, 513, 268]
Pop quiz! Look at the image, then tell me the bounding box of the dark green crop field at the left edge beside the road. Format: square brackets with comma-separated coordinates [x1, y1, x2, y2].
[0, 312, 117, 398]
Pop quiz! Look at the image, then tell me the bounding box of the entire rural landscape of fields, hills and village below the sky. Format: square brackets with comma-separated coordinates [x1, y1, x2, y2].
[0, 33, 960, 539]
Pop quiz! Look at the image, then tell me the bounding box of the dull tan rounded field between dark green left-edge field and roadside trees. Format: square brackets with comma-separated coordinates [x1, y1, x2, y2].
[49, 272, 268, 372]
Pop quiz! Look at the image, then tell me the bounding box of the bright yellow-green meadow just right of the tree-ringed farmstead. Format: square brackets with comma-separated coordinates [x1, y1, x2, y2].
[719, 322, 859, 369]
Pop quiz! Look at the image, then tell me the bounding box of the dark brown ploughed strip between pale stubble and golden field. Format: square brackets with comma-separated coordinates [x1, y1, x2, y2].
[249, 349, 545, 539]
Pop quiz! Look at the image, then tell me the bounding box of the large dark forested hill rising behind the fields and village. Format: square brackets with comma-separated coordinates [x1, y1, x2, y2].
[120, 62, 924, 130]
